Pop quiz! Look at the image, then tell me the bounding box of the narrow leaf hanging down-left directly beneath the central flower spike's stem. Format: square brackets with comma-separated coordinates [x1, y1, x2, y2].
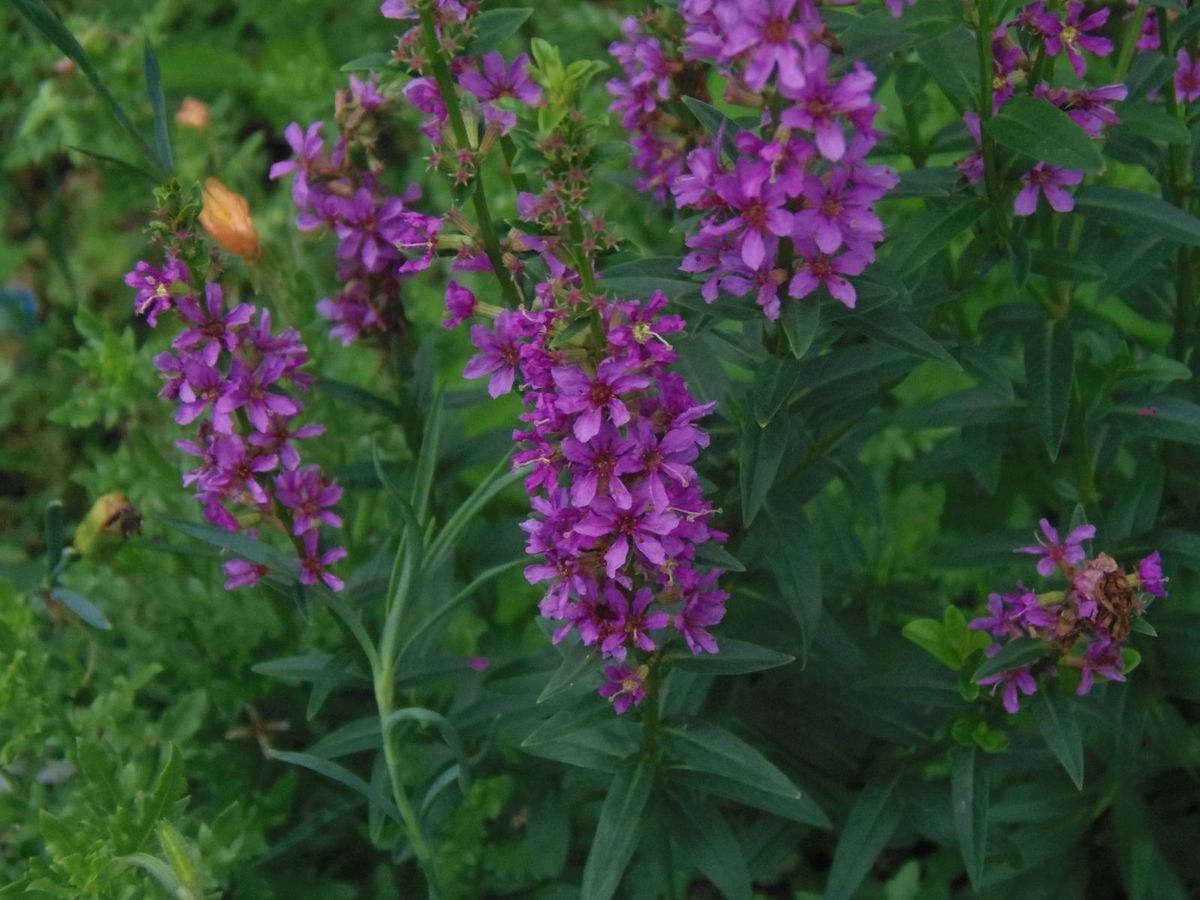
[581, 757, 654, 900]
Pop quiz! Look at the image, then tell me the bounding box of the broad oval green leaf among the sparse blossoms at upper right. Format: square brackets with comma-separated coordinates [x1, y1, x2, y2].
[983, 97, 1104, 172]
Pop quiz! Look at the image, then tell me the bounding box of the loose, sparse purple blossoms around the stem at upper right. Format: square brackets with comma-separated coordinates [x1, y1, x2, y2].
[959, 0, 1128, 216]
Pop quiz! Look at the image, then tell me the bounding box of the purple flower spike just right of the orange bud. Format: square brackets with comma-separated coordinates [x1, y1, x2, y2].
[270, 77, 442, 344]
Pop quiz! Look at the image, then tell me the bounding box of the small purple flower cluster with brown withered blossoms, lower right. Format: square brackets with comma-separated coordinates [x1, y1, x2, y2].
[971, 518, 1166, 713]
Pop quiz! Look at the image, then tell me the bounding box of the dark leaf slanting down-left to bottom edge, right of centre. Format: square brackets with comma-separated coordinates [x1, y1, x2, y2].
[824, 773, 907, 900]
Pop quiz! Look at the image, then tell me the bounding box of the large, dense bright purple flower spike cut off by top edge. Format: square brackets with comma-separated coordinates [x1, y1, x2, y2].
[610, 0, 896, 319]
